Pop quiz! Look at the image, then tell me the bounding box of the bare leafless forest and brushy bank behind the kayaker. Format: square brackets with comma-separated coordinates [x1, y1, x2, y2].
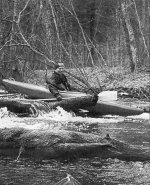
[0, 0, 150, 98]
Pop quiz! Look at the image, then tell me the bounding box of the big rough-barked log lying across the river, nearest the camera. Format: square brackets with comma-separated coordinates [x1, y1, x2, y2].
[0, 128, 150, 161]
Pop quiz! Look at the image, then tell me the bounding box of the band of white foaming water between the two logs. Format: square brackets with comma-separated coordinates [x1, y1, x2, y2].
[0, 107, 149, 134]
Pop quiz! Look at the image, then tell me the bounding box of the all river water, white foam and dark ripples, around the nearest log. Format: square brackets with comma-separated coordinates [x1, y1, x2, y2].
[0, 108, 150, 185]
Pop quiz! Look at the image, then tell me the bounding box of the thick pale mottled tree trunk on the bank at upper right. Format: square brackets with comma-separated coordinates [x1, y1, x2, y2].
[121, 3, 138, 72]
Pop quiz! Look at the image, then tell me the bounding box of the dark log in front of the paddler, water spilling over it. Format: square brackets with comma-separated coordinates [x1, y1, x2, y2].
[0, 95, 98, 116]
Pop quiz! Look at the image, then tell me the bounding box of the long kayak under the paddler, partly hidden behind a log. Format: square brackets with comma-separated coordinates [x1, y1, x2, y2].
[2, 79, 144, 116]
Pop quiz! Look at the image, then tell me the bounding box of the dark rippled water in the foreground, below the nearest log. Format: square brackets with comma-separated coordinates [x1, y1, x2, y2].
[0, 155, 150, 185]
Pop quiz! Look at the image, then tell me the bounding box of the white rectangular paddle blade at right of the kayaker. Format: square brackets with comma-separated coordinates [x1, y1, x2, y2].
[98, 91, 117, 101]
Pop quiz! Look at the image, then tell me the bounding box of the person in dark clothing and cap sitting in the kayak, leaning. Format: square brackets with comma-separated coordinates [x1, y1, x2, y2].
[46, 63, 75, 101]
